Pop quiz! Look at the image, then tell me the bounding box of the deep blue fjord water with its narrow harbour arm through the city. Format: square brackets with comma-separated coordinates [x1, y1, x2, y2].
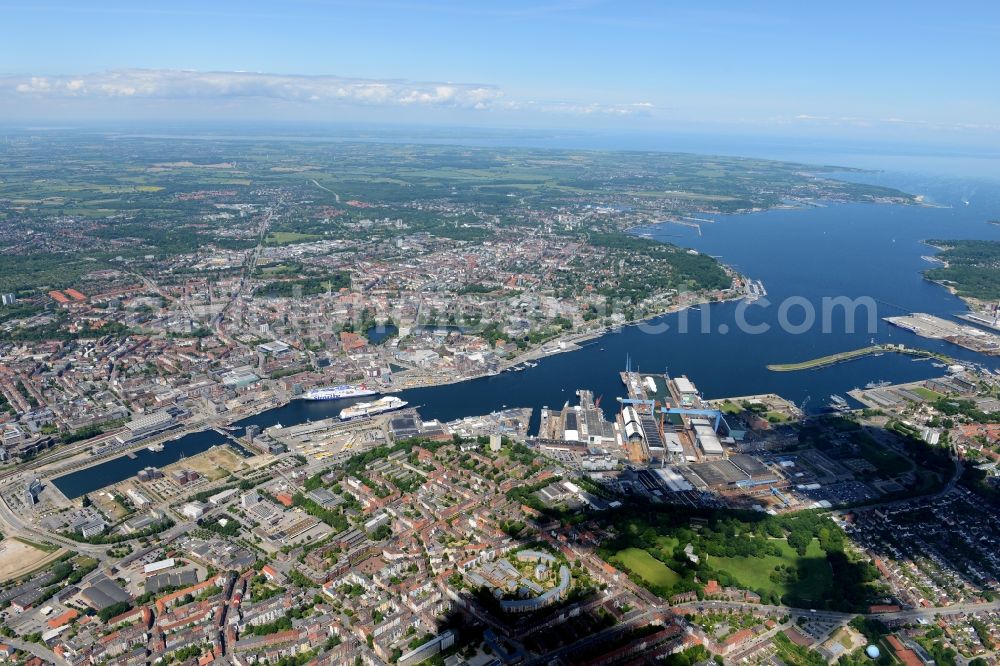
[55, 169, 1000, 498]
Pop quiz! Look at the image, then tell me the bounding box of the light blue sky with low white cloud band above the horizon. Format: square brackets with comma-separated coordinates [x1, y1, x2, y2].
[0, 0, 1000, 145]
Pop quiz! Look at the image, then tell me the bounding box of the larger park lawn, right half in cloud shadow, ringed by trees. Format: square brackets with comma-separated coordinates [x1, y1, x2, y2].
[708, 539, 833, 601]
